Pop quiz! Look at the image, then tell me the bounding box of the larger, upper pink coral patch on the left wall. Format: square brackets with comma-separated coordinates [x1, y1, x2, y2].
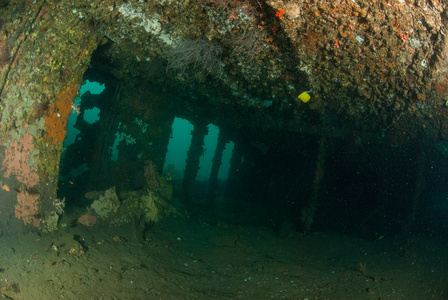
[3, 129, 39, 188]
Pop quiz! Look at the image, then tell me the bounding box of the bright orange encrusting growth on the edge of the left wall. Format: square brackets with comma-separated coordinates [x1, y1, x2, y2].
[45, 84, 78, 146]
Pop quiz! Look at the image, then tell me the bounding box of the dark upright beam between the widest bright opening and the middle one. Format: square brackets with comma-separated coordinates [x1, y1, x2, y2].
[182, 122, 208, 204]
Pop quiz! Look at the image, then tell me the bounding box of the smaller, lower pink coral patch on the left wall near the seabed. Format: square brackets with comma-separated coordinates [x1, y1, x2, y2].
[14, 192, 40, 227]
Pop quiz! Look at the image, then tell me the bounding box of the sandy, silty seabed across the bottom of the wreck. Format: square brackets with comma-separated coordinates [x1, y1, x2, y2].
[0, 217, 448, 300]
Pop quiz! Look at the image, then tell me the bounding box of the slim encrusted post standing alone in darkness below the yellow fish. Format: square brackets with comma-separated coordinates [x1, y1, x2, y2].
[300, 136, 327, 234]
